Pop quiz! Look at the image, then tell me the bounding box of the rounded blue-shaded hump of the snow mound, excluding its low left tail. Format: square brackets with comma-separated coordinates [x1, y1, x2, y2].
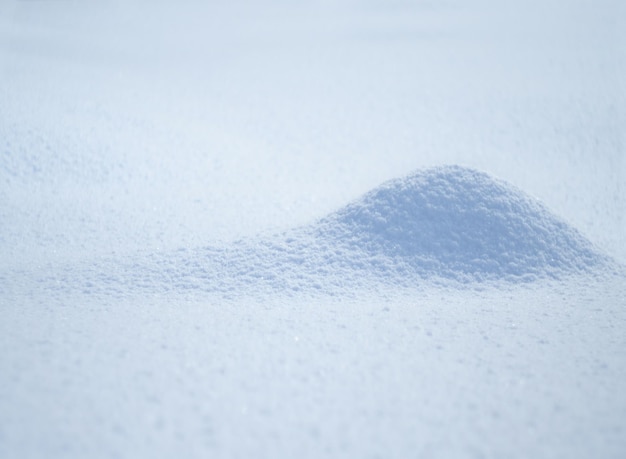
[315, 166, 605, 278]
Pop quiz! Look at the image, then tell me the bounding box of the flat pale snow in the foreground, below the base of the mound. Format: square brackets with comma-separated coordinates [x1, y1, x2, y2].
[0, 279, 626, 458]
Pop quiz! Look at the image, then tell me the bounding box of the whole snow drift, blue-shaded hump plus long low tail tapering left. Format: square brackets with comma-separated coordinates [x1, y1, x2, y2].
[24, 166, 609, 295]
